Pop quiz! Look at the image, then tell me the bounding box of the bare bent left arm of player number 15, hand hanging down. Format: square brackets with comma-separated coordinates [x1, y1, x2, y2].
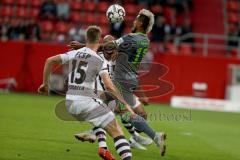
[38, 55, 62, 94]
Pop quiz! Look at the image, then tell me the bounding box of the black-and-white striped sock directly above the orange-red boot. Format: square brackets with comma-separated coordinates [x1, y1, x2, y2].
[93, 127, 108, 149]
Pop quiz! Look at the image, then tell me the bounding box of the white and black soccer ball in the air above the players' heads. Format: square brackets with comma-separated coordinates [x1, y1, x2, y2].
[106, 4, 125, 23]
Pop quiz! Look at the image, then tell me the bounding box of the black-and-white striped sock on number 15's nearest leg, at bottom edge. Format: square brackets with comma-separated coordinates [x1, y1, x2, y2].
[114, 136, 132, 160]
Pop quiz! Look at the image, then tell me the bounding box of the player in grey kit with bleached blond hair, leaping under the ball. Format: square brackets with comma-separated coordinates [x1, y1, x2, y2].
[71, 9, 166, 156]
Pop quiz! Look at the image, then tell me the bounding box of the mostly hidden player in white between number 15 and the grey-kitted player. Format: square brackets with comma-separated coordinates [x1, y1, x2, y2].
[75, 35, 152, 150]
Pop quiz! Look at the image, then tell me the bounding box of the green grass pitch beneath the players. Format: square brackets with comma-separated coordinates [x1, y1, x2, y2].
[0, 94, 240, 160]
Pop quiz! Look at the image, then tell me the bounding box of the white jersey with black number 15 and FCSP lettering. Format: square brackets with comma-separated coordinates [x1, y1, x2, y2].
[60, 47, 108, 100]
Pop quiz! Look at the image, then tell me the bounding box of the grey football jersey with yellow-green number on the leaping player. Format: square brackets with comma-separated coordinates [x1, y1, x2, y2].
[113, 33, 150, 88]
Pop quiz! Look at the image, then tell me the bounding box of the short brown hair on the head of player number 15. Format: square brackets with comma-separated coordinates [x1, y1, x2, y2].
[86, 26, 102, 43]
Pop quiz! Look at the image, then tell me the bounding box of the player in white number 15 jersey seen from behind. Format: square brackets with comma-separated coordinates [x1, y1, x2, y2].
[38, 26, 135, 160]
